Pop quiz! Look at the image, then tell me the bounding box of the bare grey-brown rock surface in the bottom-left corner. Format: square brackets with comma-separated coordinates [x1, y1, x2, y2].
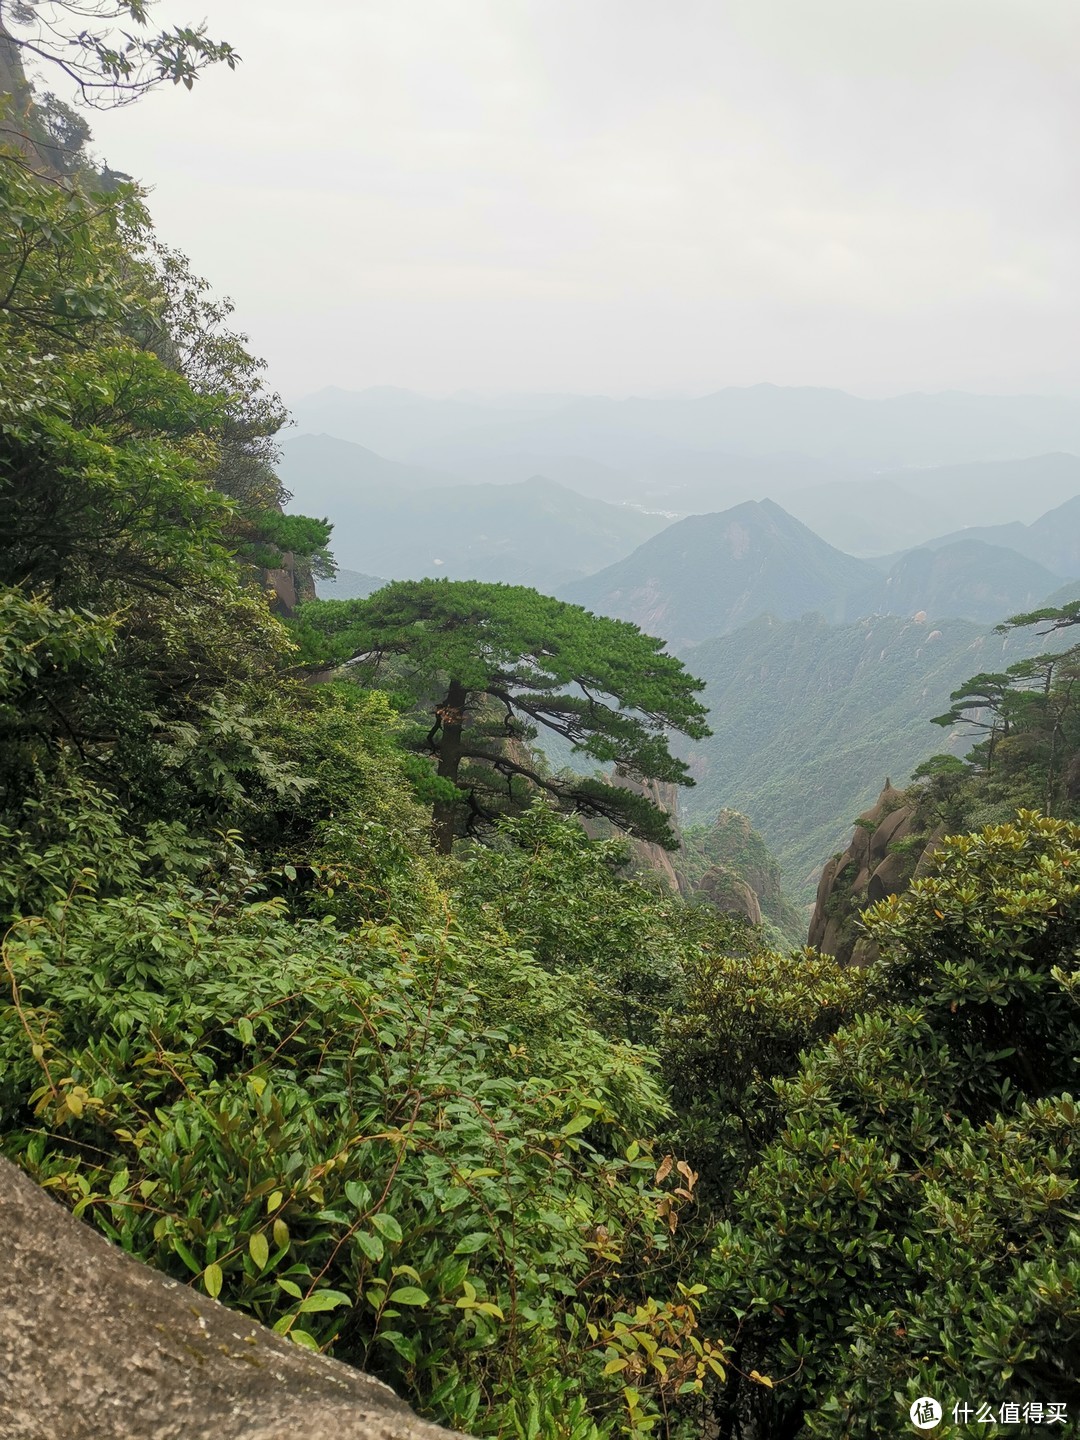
[0, 1159, 451, 1440]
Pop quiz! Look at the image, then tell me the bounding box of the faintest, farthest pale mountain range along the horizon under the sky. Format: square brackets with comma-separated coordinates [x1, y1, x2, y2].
[294, 384, 1080, 472]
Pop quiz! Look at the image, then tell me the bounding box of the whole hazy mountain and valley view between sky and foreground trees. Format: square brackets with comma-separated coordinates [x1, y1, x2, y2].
[293, 390, 1080, 907]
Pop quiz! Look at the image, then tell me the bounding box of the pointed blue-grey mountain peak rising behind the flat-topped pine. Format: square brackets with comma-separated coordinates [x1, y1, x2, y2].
[560, 500, 878, 649]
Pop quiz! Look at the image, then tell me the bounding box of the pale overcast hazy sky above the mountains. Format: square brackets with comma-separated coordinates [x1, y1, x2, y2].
[84, 0, 1080, 399]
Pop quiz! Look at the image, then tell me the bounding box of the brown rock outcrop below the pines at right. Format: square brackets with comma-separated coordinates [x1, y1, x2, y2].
[808, 779, 942, 965]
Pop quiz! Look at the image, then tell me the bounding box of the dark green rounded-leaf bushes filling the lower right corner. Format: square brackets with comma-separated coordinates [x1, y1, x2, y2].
[713, 814, 1080, 1437]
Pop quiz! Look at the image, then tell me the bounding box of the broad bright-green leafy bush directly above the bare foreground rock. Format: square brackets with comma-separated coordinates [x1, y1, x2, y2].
[0, 857, 721, 1440]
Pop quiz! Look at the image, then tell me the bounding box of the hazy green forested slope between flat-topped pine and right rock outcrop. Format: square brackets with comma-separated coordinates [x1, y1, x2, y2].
[683, 615, 1045, 901]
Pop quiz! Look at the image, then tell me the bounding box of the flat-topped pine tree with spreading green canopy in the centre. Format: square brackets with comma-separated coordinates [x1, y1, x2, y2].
[301, 580, 708, 851]
